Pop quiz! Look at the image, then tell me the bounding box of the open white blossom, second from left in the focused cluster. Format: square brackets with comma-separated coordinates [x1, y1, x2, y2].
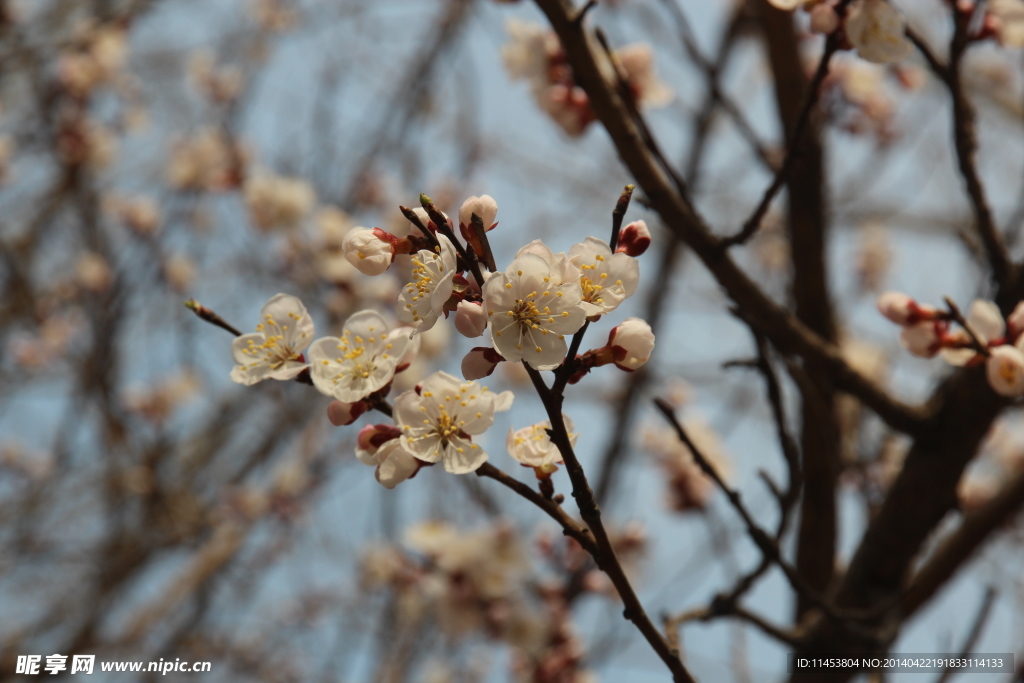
[309, 310, 409, 402]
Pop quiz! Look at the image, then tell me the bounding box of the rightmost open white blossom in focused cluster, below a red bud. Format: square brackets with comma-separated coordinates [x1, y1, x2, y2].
[569, 238, 640, 315]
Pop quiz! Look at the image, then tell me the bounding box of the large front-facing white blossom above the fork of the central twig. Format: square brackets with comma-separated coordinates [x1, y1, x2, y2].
[483, 241, 587, 370]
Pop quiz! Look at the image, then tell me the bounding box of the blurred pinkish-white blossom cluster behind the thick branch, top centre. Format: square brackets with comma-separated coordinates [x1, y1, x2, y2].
[502, 19, 673, 136]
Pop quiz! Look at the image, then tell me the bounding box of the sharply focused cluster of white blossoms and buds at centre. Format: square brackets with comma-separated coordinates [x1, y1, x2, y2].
[231, 195, 654, 488]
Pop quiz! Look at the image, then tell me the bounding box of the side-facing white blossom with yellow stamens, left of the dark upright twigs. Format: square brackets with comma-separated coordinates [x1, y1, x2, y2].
[398, 234, 457, 333]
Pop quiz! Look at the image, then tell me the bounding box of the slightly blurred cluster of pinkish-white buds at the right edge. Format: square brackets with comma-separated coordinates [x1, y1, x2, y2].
[878, 292, 1024, 398]
